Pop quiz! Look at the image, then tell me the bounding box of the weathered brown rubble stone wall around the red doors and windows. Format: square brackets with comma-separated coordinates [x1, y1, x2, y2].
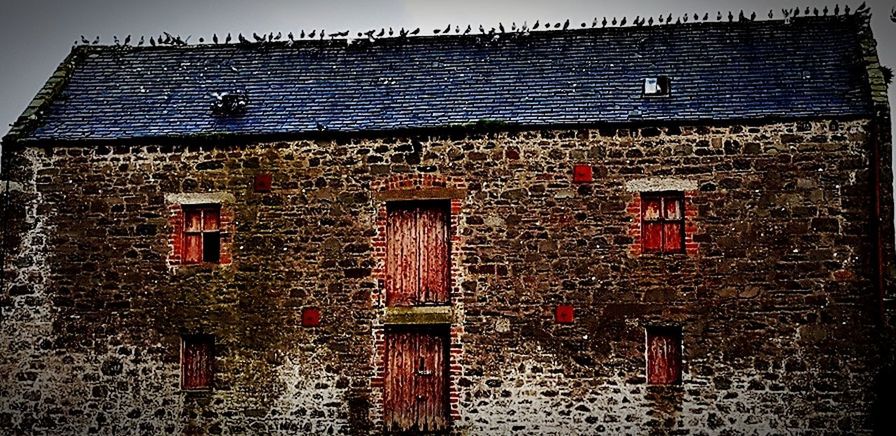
[0, 120, 892, 434]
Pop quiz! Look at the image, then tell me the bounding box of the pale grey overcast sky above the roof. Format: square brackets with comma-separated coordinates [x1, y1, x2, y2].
[0, 0, 896, 135]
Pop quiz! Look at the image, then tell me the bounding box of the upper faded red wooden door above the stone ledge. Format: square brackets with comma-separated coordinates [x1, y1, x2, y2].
[386, 201, 450, 306]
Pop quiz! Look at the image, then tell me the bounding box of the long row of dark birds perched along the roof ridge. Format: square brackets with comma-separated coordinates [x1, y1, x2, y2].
[75, 2, 896, 47]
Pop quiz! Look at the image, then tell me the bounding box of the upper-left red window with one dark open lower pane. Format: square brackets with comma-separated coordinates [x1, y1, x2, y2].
[182, 205, 221, 263]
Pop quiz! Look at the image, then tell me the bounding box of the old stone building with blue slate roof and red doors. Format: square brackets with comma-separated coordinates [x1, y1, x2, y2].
[0, 10, 893, 435]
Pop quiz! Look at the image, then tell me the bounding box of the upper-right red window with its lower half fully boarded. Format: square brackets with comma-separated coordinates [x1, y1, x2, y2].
[641, 191, 684, 253]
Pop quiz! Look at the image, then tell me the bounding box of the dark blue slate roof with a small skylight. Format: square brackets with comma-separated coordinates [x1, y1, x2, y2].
[5, 17, 871, 140]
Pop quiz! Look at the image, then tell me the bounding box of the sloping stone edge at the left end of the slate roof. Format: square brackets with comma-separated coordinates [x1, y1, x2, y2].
[2, 46, 90, 145]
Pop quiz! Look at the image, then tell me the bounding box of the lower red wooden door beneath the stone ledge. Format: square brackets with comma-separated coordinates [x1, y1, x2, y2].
[383, 329, 448, 432]
